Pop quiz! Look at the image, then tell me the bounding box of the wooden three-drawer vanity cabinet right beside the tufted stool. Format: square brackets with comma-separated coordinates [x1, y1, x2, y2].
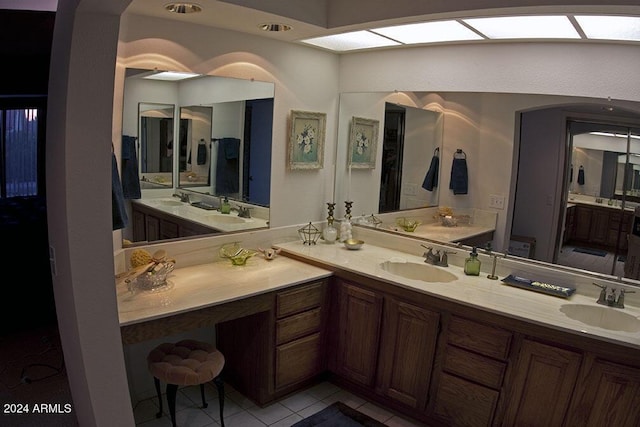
[216, 280, 328, 405]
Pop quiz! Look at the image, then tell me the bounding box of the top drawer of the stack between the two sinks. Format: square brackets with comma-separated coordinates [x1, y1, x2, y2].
[449, 317, 511, 360]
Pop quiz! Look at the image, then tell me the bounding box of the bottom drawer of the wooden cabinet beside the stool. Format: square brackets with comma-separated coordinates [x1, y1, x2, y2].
[276, 334, 321, 389]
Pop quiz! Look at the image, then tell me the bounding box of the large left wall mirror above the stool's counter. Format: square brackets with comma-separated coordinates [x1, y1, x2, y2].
[123, 69, 275, 242]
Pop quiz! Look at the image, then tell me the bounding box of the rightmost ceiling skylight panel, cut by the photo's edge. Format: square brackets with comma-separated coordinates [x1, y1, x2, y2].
[575, 15, 640, 41]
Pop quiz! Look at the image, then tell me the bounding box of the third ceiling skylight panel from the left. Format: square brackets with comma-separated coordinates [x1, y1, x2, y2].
[463, 16, 580, 39]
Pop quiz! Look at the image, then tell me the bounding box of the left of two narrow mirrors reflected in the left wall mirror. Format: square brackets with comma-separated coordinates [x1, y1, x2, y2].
[138, 102, 174, 188]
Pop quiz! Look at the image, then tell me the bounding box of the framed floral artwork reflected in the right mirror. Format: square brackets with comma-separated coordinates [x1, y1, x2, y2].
[349, 117, 380, 169]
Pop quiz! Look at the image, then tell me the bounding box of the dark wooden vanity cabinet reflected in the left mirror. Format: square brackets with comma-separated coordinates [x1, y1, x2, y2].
[131, 202, 219, 242]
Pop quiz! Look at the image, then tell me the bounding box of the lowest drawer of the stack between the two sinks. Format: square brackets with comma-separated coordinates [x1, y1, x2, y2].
[435, 373, 498, 427]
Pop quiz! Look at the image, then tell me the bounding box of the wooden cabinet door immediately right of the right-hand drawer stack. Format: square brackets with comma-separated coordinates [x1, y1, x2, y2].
[504, 340, 582, 427]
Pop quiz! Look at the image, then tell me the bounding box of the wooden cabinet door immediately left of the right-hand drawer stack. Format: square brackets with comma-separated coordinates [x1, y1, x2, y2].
[377, 298, 440, 409]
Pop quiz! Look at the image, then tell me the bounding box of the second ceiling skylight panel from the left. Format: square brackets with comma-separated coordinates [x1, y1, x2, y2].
[371, 21, 482, 44]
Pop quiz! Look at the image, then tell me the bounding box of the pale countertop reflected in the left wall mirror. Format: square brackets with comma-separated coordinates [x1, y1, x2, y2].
[132, 197, 268, 232]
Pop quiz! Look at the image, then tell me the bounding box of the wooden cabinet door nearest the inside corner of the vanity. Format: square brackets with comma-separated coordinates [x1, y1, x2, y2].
[336, 282, 383, 386]
